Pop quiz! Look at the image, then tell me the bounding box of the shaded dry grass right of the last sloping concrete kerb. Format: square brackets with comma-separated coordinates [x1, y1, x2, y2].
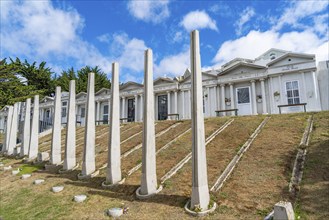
[295, 111, 329, 219]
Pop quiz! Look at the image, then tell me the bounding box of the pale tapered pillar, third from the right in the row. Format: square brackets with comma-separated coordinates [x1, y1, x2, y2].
[103, 63, 121, 186]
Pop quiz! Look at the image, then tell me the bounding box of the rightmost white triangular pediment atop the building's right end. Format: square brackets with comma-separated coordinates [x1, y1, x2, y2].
[267, 53, 315, 67]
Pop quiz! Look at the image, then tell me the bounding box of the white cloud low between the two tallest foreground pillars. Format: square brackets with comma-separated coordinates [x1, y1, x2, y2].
[154, 46, 190, 77]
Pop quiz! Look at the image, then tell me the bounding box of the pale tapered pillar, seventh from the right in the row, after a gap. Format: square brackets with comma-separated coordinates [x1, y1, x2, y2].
[28, 95, 39, 160]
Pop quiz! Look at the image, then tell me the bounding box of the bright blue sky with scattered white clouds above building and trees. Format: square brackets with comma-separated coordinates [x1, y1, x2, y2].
[0, 0, 329, 82]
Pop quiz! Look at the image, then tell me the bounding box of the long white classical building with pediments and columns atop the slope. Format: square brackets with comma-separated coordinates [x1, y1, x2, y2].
[0, 49, 329, 129]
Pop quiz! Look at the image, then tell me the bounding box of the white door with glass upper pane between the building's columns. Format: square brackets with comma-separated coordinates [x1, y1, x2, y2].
[236, 86, 251, 115]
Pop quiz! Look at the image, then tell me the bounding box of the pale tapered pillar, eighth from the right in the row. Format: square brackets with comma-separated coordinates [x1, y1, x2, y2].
[20, 98, 31, 157]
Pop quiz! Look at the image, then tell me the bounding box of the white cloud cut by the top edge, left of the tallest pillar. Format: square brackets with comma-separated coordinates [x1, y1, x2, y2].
[127, 0, 170, 24]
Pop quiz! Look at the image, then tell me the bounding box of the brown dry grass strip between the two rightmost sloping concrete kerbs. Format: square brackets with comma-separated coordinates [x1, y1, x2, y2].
[216, 114, 308, 219]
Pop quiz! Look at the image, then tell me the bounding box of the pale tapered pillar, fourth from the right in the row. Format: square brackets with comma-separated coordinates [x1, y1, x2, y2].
[78, 73, 97, 179]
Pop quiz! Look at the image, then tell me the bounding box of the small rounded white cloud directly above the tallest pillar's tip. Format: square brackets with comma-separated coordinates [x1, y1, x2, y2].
[180, 10, 218, 31]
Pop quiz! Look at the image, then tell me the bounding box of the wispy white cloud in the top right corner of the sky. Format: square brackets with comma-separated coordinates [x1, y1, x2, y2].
[273, 1, 329, 30]
